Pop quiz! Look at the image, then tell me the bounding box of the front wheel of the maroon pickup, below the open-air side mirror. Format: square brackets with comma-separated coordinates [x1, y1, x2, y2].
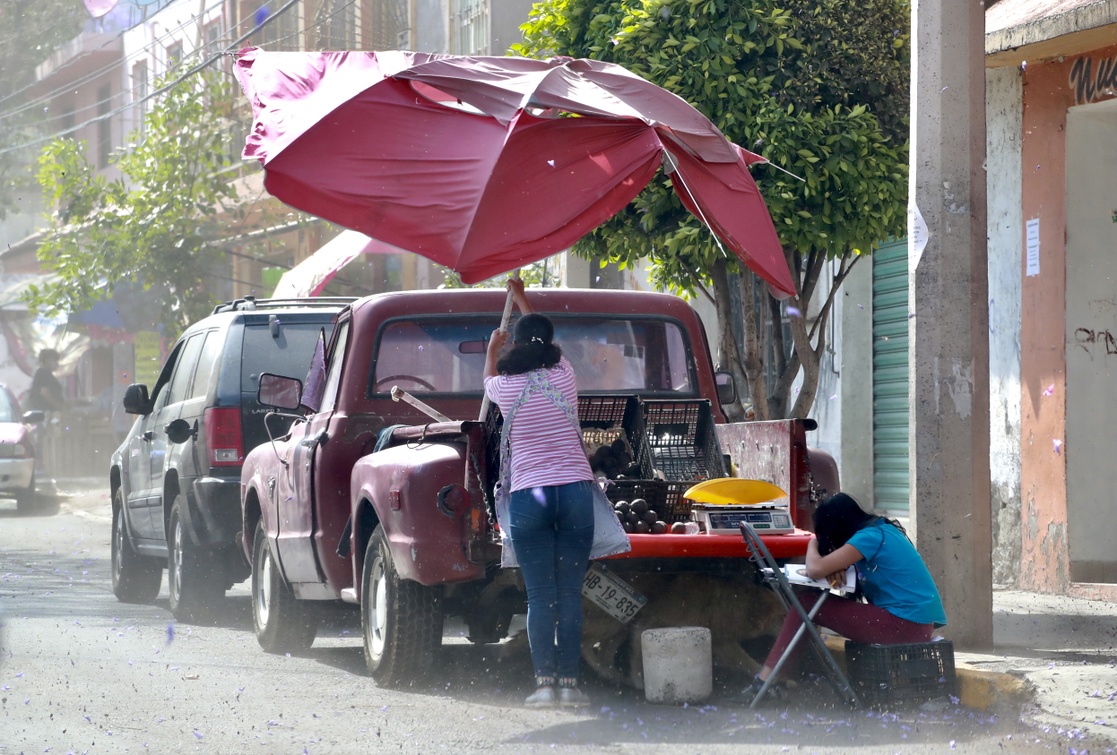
[252, 519, 318, 653]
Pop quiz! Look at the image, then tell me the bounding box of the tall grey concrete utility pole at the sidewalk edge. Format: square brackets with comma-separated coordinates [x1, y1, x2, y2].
[908, 0, 993, 649]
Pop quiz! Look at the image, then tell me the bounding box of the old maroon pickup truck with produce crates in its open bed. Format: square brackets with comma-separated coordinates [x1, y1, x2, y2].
[241, 289, 837, 685]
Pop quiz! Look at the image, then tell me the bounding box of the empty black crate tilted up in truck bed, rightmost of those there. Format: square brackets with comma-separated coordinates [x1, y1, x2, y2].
[641, 399, 727, 482]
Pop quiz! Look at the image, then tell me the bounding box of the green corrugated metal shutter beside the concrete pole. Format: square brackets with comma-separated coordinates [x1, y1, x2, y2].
[871, 239, 909, 515]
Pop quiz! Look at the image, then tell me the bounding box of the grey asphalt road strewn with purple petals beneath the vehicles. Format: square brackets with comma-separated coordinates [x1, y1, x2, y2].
[0, 489, 1102, 754]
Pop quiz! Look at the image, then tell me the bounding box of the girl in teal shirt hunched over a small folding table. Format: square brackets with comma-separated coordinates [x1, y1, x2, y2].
[735, 493, 946, 704]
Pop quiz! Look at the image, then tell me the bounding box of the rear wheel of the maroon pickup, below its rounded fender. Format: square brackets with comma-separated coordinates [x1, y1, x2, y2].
[361, 526, 442, 687]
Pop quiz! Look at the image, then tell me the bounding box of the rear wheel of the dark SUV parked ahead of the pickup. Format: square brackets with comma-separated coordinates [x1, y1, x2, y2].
[166, 493, 225, 622]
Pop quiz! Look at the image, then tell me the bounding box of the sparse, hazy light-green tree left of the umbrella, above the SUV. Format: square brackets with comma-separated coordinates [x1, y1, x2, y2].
[28, 66, 251, 335]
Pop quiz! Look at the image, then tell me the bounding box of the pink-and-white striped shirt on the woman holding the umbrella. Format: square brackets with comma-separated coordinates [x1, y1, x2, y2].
[485, 356, 593, 490]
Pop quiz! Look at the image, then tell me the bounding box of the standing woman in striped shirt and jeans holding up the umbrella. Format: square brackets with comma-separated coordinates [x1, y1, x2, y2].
[485, 278, 596, 708]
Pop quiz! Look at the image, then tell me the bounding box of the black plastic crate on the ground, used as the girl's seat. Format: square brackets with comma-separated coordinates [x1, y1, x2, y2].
[846, 640, 957, 706]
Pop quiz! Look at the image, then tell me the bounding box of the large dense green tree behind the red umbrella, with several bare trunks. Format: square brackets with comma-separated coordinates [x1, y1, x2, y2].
[513, 0, 910, 419]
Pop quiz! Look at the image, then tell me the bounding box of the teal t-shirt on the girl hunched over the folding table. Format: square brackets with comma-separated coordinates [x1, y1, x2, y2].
[849, 522, 946, 627]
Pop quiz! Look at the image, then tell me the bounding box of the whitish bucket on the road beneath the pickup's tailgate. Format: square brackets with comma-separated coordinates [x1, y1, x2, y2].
[640, 627, 714, 705]
